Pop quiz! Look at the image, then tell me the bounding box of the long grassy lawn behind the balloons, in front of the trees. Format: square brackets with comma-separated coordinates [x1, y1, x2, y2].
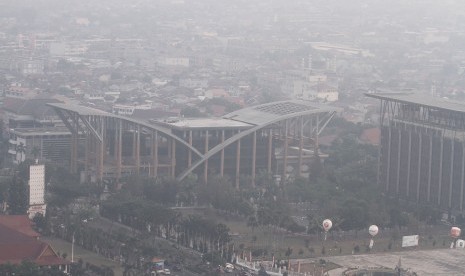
[177, 209, 452, 260]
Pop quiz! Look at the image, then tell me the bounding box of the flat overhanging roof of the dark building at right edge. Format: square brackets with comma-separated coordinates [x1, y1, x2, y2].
[365, 93, 465, 112]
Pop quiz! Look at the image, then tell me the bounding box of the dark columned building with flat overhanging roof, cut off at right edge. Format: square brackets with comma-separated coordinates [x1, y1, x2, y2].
[366, 93, 465, 212]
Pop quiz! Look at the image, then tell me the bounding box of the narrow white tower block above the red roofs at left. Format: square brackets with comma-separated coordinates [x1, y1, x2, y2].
[27, 164, 46, 218]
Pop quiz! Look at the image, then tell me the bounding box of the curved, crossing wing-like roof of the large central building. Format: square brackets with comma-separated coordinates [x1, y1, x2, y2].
[49, 100, 340, 180]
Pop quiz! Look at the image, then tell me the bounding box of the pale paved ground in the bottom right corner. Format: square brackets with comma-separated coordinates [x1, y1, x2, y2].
[325, 249, 465, 276]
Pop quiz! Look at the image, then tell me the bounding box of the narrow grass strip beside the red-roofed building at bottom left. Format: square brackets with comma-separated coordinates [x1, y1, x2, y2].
[41, 237, 123, 276]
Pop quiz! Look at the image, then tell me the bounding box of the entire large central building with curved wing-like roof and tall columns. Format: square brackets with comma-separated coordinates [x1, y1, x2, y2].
[48, 101, 338, 185]
